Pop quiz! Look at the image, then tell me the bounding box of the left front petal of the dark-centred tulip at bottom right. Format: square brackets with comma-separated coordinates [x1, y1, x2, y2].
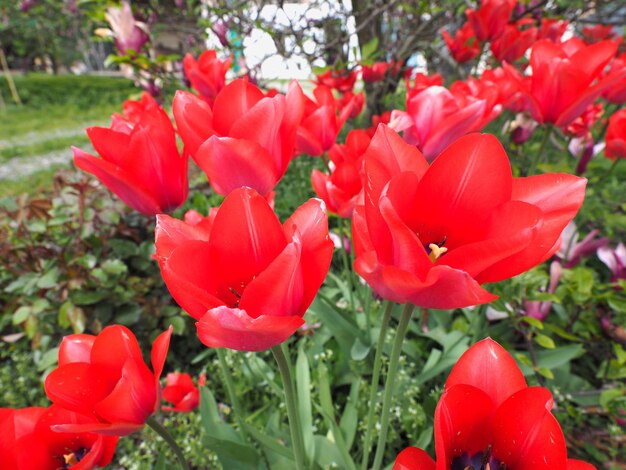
[435, 384, 496, 468]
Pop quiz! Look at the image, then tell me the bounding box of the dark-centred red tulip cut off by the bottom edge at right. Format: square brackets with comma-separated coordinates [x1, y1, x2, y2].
[393, 338, 595, 470]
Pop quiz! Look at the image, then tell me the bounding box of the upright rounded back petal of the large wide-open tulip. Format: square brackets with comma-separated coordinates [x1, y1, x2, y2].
[411, 134, 513, 250]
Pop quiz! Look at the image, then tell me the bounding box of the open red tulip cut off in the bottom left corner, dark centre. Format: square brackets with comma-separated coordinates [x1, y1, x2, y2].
[0, 405, 119, 470]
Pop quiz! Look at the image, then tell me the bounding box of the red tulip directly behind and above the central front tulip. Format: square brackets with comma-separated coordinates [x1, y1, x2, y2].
[173, 79, 304, 196]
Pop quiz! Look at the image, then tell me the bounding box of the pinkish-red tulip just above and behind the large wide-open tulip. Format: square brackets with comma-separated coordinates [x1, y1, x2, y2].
[389, 86, 496, 160]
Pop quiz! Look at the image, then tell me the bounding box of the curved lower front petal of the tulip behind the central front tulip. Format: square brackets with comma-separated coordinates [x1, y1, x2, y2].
[196, 136, 282, 195]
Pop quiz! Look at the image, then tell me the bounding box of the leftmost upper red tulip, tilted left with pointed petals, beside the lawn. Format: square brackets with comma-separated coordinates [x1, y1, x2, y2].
[72, 93, 188, 216]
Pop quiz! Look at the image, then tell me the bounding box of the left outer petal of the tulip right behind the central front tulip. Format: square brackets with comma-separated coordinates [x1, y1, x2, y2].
[172, 90, 215, 158]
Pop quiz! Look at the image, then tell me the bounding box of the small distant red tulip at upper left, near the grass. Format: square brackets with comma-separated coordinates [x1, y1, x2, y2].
[183, 49, 233, 104]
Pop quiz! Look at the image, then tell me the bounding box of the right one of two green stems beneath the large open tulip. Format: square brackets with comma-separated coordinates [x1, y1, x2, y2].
[372, 303, 415, 470]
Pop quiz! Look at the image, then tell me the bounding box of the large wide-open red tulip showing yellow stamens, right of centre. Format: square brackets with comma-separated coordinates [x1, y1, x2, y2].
[352, 126, 587, 309]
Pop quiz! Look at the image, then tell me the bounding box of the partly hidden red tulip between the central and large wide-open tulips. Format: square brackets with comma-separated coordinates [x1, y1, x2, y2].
[311, 129, 371, 218]
